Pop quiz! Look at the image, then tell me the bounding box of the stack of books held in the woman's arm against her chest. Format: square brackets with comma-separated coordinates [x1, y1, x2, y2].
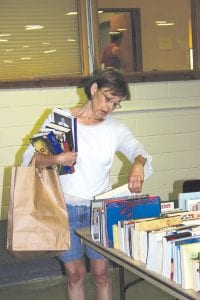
[30, 108, 78, 175]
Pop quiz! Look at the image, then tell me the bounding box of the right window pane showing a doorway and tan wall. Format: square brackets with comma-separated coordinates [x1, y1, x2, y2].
[98, 0, 193, 72]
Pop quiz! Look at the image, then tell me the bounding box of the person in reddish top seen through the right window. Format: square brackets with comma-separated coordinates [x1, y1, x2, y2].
[101, 31, 126, 70]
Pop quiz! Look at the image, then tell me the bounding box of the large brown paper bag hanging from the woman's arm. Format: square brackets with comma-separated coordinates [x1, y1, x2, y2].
[7, 164, 70, 256]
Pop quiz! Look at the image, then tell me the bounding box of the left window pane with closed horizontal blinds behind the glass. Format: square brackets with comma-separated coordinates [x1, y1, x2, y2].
[0, 0, 82, 81]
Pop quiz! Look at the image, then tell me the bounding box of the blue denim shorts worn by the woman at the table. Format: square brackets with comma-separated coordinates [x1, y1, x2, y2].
[58, 204, 105, 262]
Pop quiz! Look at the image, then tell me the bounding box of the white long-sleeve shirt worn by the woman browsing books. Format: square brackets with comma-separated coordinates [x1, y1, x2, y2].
[23, 109, 152, 202]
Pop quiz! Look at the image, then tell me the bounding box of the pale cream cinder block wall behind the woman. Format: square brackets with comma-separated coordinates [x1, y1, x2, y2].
[0, 81, 200, 219]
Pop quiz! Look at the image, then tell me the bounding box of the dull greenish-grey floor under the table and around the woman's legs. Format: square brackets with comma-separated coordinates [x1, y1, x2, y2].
[0, 270, 177, 300]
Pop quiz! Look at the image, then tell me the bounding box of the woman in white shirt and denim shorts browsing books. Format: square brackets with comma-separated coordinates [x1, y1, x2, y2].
[24, 68, 152, 300]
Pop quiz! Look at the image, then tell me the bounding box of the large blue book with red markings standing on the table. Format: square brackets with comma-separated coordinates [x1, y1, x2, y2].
[104, 196, 161, 247]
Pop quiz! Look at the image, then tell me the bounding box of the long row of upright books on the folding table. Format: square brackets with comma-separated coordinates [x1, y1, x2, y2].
[91, 187, 200, 292]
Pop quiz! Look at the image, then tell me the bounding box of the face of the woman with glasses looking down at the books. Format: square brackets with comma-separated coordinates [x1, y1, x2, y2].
[91, 83, 122, 118]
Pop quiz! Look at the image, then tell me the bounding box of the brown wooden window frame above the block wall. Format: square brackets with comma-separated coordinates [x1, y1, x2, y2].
[0, 0, 200, 89]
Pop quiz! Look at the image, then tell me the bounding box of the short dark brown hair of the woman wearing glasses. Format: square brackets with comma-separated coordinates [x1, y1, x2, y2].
[84, 67, 130, 100]
